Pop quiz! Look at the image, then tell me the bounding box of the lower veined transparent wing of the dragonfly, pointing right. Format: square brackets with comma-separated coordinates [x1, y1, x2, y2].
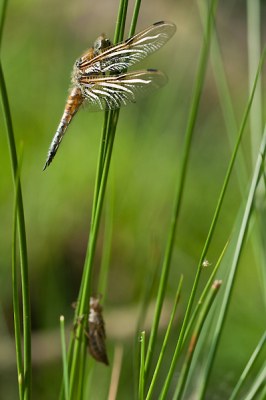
[80, 69, 167, 112]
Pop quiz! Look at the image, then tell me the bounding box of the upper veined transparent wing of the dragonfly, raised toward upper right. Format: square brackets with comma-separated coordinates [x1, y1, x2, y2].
[79, 21, 176, 75]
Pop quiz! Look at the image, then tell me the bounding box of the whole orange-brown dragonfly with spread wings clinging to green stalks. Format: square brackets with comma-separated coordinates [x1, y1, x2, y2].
[43, 21, 176, 170]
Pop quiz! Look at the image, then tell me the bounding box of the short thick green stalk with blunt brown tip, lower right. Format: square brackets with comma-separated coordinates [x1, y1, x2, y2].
[173, 281, 222, 400]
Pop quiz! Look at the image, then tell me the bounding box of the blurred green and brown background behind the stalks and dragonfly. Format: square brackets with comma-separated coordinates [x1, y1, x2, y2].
[0, 0, 265, 400]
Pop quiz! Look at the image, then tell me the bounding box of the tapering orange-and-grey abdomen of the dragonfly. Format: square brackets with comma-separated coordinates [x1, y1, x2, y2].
[43, 86, 82, 171]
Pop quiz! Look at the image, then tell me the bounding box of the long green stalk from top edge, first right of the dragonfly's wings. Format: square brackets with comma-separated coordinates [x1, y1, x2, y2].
[145, 0, 217, 382]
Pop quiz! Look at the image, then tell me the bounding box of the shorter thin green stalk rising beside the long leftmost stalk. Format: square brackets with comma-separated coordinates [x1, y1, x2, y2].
[12, 146, 24, 400]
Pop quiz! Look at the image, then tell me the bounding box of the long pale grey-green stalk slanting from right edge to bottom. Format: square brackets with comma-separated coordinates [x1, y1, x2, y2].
[198, 125, 266, 400]
